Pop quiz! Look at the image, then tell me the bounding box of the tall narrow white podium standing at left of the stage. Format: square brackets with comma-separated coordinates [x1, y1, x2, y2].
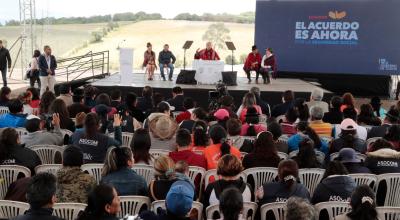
[119, 48, 133, 86]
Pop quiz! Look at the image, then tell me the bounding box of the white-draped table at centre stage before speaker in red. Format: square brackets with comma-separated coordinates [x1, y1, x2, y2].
[193, 60, 225, 84]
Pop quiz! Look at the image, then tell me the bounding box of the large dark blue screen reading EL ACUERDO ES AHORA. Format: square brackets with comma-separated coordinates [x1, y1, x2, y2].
[255, 0, 400, 75]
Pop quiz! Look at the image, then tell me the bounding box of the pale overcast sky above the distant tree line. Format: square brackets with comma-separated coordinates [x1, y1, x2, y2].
[0, 0, 256, 22]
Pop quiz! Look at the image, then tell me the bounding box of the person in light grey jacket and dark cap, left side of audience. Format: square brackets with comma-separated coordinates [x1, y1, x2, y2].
[21, 114, 64, 148]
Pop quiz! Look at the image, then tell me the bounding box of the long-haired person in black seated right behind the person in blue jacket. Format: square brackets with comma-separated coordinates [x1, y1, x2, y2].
[293, 137, 322, 169]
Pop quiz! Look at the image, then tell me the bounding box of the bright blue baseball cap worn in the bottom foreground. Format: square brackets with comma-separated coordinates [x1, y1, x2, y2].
[165, 180, 194, 216]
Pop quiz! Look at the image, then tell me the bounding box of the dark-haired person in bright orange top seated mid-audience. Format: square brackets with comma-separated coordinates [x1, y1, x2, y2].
[204, 125, 241, 170]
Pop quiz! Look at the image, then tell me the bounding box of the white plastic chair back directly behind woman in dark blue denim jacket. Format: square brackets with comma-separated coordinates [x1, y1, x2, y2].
[117, 196, 151, 218]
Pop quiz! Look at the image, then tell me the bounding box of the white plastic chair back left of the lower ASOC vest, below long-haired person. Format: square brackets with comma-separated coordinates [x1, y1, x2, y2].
[299, 168, 325, 196]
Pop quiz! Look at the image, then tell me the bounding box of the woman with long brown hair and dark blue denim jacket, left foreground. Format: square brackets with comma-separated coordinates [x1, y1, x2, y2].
[101, 147, 148, 196]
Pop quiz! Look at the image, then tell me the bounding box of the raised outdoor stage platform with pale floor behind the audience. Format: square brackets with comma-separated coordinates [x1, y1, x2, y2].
[91, 73, 333, 107]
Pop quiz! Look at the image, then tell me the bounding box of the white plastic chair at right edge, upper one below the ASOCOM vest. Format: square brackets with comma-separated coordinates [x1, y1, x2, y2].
[375, 173, 400, 207]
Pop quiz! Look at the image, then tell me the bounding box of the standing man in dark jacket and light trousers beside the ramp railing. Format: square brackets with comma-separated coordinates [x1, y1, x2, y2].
[39, 45, 57, 95]
